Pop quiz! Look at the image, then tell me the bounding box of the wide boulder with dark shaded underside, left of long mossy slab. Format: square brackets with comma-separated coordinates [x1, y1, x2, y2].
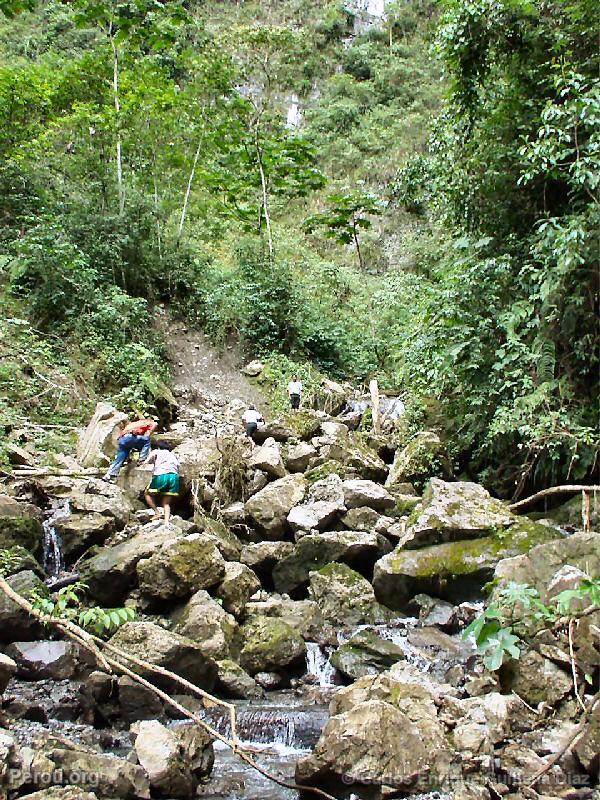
[273, 531, 391, 594]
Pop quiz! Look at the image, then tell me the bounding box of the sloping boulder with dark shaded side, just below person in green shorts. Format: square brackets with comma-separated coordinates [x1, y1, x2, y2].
[79, 526, 183, 607]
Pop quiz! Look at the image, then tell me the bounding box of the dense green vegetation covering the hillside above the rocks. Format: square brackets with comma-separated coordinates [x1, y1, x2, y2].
[0, 0, 600, 495]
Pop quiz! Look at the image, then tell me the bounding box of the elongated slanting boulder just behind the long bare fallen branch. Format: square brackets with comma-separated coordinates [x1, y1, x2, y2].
[110, 622, 216, 691]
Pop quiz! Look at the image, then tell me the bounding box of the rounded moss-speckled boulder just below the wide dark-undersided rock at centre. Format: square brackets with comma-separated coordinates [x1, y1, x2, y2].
[309, 564, 392, 625]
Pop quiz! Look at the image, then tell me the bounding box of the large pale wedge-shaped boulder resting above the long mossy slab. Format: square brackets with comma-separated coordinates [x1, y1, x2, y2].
[404, 478, 516, 547]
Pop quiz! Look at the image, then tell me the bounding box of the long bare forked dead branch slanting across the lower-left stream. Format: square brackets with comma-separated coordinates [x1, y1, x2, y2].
[0, 576, 337, 800]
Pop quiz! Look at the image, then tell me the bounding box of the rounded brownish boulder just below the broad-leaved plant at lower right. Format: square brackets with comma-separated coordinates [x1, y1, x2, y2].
[501, 650, 573, 706]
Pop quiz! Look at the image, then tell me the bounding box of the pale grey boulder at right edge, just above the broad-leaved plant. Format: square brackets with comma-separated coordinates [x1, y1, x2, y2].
[495, 532, 600, 601]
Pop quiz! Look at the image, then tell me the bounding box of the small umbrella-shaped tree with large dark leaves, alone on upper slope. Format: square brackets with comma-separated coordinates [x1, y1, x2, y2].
[302, 190, 383, 269]
